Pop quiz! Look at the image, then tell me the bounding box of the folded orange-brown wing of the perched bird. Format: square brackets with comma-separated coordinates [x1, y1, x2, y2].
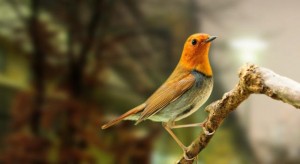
[136, 74, 196, 124]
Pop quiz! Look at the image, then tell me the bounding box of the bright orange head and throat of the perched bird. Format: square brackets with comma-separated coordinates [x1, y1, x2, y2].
[179, 33, 217, 76]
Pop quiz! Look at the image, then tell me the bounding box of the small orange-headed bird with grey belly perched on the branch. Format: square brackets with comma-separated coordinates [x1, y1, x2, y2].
[101, 33, 217, 159]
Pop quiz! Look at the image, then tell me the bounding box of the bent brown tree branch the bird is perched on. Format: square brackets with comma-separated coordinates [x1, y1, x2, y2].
[177, 64, 300, 164]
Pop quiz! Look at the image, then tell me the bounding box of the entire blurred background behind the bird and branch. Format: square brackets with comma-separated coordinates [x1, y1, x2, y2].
[0, 0, 300, 164]
